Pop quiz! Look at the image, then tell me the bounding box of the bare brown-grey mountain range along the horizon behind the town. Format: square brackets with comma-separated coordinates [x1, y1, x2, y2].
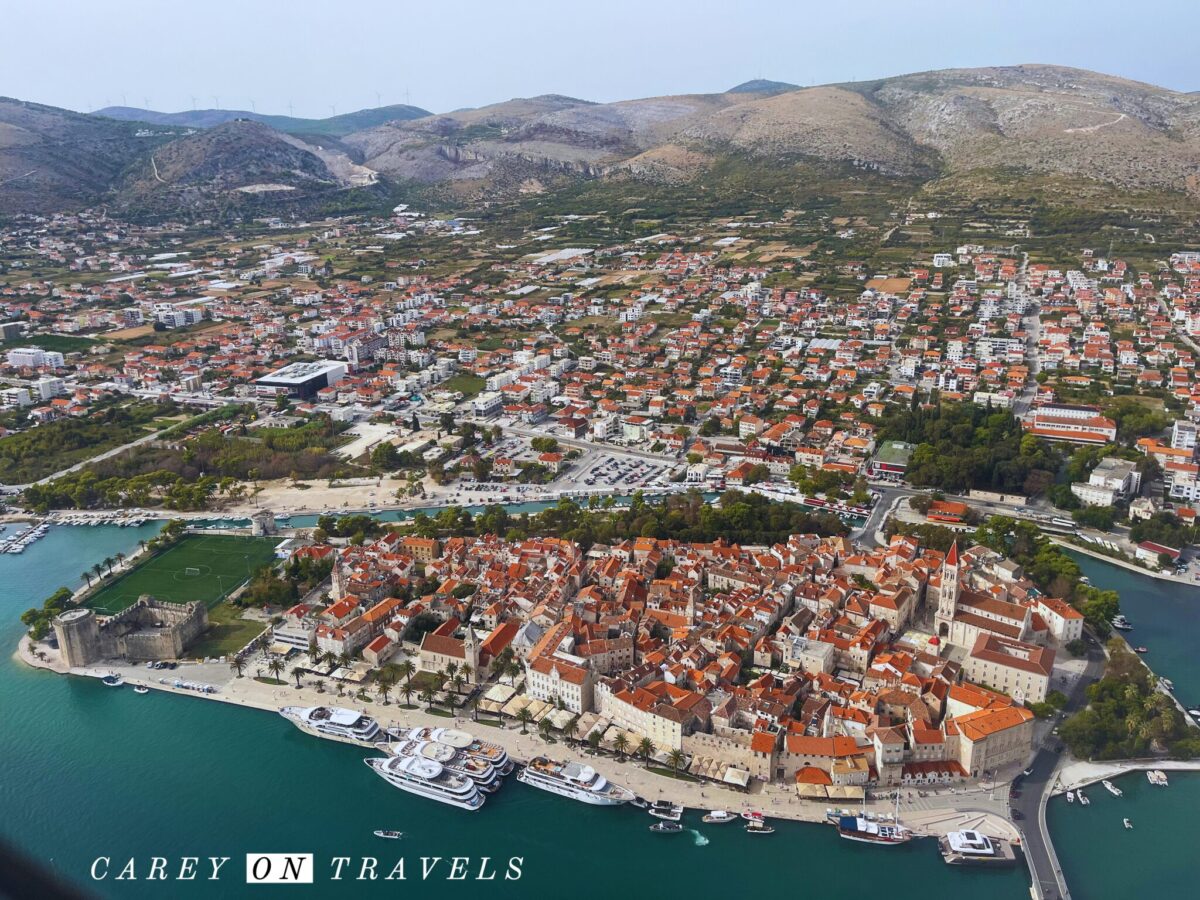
[0, 65, 1200, 212]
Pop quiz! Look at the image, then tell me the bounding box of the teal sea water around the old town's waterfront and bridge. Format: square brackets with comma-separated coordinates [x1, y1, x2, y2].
[0, 523, 1180, 900]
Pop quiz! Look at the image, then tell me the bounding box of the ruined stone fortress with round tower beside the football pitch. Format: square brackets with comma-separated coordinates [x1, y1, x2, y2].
[54, 594, 209, 668]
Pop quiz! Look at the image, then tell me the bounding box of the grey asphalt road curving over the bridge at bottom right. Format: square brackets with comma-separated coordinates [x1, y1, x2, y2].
[1013, 641, 1104, 900]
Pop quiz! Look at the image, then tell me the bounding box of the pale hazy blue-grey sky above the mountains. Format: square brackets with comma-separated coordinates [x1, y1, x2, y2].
[0, 0, 1200, 116]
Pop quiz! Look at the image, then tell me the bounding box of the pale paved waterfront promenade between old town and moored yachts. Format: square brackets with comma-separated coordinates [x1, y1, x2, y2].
[16, 637, 1019, 839]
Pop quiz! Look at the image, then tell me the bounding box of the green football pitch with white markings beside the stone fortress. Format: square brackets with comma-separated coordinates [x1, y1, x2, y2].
[84, 534, 278, 614]
